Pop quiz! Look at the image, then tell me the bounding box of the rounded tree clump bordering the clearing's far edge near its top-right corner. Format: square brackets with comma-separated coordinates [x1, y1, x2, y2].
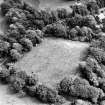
[67, 26, 99, 42]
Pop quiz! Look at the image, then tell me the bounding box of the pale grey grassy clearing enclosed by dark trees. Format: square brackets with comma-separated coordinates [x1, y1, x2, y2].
[16, 38, 88, 85]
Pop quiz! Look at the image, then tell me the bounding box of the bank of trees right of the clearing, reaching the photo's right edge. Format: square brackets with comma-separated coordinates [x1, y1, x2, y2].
[80, 37, 105, 96]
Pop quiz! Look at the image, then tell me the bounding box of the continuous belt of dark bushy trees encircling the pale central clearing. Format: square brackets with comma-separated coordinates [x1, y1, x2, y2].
[0, 0, 105, 105]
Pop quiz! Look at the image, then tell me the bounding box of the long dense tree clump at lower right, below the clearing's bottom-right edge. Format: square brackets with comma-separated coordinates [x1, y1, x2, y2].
[60, 77, 104, 103]
